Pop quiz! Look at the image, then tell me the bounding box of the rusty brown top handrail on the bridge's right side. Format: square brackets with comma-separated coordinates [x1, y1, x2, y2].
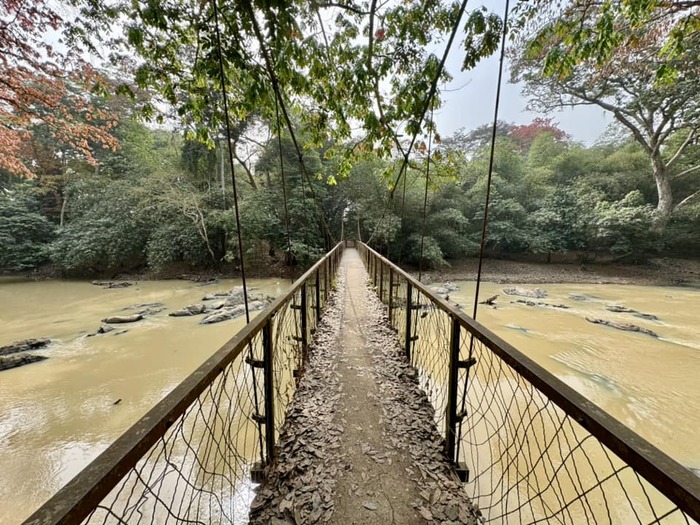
[358, 243, 700, 522]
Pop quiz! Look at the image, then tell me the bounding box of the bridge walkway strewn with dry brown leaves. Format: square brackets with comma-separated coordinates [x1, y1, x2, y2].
[251, 249, 476, 524]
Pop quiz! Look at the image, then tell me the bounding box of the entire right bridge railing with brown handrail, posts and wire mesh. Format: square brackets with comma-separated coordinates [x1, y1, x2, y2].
[358, 243, 700, 525]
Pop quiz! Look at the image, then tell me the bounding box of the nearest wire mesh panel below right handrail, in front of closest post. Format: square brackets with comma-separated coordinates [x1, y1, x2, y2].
[457, 329, 694, 524]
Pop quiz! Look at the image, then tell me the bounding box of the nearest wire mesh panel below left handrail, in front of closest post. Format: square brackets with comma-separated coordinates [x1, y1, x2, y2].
[86, 333, 264, 524]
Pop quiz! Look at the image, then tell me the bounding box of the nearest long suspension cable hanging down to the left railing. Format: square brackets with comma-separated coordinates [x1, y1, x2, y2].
[212, 0, 264, 463]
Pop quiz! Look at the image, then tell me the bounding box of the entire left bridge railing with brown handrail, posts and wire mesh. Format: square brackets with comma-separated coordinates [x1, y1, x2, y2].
[25, 244, 343, 525]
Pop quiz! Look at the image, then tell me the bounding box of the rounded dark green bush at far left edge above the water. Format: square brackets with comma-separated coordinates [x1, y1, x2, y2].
[0, 187, 54, 271]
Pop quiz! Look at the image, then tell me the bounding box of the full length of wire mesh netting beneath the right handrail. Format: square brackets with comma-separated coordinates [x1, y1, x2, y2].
[360, 245, 696, 524]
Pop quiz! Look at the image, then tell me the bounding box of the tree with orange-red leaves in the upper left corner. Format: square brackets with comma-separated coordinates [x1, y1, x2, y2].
[0, 0, 117, 177]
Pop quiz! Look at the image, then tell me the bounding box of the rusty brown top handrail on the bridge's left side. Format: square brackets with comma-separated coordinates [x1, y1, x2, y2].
[24, 242, 344, 525]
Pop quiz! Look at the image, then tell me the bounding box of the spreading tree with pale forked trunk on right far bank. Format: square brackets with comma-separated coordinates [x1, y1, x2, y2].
[512, 7, 700, 232]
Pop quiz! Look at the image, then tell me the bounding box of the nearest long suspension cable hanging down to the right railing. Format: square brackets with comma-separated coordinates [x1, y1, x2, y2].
[455, 0, 510, 461]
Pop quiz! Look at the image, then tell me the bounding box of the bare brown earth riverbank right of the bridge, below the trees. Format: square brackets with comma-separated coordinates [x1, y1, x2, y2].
[422, 258, 700, 286]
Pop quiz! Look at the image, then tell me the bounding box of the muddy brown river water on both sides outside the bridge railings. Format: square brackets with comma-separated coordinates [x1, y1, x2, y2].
[0, 279, 700, 524]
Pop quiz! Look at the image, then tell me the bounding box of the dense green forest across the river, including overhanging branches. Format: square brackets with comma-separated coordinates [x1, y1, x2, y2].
[0, 0, 700, 276]
